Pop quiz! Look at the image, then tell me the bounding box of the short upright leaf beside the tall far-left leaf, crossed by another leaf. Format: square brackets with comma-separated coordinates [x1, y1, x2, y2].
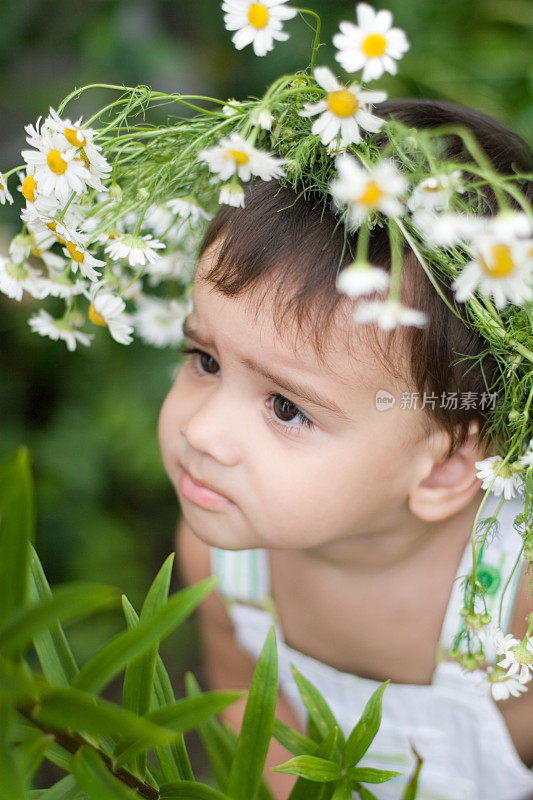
[28, 545, 78, 686]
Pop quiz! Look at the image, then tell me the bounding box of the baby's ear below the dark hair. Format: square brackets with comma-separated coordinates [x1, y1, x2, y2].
[408, 420, 484, 522]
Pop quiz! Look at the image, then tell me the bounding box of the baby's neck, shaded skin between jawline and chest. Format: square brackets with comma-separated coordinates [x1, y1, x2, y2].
[301, 490, 484, 574]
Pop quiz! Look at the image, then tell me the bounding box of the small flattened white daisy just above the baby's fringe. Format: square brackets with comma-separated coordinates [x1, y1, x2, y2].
[198, 133, 285, 181]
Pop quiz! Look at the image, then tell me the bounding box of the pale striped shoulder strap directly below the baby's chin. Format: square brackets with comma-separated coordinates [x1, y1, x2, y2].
[211, 547, 270, 605]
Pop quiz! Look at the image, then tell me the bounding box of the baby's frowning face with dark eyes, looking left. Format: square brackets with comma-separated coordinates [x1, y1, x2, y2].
[159, 247, 432, 549]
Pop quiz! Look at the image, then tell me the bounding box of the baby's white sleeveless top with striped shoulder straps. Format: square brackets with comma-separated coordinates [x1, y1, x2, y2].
[207, 494, 533, 800]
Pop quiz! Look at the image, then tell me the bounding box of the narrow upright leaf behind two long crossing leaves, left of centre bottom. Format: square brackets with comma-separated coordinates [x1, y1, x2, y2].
[122, 597, 194, 783]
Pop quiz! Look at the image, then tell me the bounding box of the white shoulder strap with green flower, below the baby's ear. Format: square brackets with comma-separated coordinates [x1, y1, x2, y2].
[440, 493, 524, 660]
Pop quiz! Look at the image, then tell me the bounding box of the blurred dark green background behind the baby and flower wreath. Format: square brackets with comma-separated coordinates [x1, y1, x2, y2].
[0, 0, 533, 788]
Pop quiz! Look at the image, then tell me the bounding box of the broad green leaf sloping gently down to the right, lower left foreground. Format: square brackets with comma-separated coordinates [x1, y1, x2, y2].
[33, 687, 182, 749]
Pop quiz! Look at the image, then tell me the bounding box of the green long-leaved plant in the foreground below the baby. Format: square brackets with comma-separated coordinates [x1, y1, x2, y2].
[0, 448, 408, 800]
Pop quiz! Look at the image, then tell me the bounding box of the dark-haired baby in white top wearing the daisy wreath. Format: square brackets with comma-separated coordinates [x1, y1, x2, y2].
[159, 100, 533, 800]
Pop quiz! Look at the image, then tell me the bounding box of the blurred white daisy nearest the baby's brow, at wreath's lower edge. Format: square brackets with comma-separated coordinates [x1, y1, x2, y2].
[132, 295, 186, 347]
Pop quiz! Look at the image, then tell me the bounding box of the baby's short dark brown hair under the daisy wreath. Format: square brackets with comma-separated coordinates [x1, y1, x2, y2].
[196, 99, 533, 456]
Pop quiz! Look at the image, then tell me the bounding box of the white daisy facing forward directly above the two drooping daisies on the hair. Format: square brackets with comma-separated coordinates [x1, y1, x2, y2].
[330, 153, 408, 227]
